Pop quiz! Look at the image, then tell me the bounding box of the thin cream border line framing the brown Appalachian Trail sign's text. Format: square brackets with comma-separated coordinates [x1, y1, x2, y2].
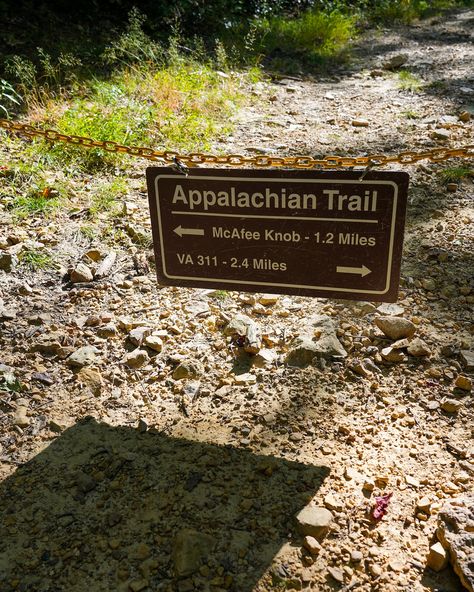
[155, 175, 398, 294]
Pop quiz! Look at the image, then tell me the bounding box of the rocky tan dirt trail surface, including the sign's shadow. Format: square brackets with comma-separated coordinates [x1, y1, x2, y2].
[0, 5, 474, 592]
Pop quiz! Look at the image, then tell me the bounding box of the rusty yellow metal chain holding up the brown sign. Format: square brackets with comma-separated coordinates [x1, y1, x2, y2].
[0, 118, 474, 169]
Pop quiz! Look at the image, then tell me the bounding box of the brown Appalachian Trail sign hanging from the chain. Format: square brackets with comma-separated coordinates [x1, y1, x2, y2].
[147, 167, 408, 302]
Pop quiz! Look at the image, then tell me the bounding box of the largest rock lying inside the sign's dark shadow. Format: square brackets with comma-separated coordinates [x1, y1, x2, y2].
[172, 529, 216, 578]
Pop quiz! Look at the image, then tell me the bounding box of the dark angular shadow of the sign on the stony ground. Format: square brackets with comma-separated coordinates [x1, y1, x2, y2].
[0, 418, 329, 592]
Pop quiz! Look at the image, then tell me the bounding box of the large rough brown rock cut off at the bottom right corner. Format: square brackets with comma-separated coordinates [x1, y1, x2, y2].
[436, 495, 474, 592]
